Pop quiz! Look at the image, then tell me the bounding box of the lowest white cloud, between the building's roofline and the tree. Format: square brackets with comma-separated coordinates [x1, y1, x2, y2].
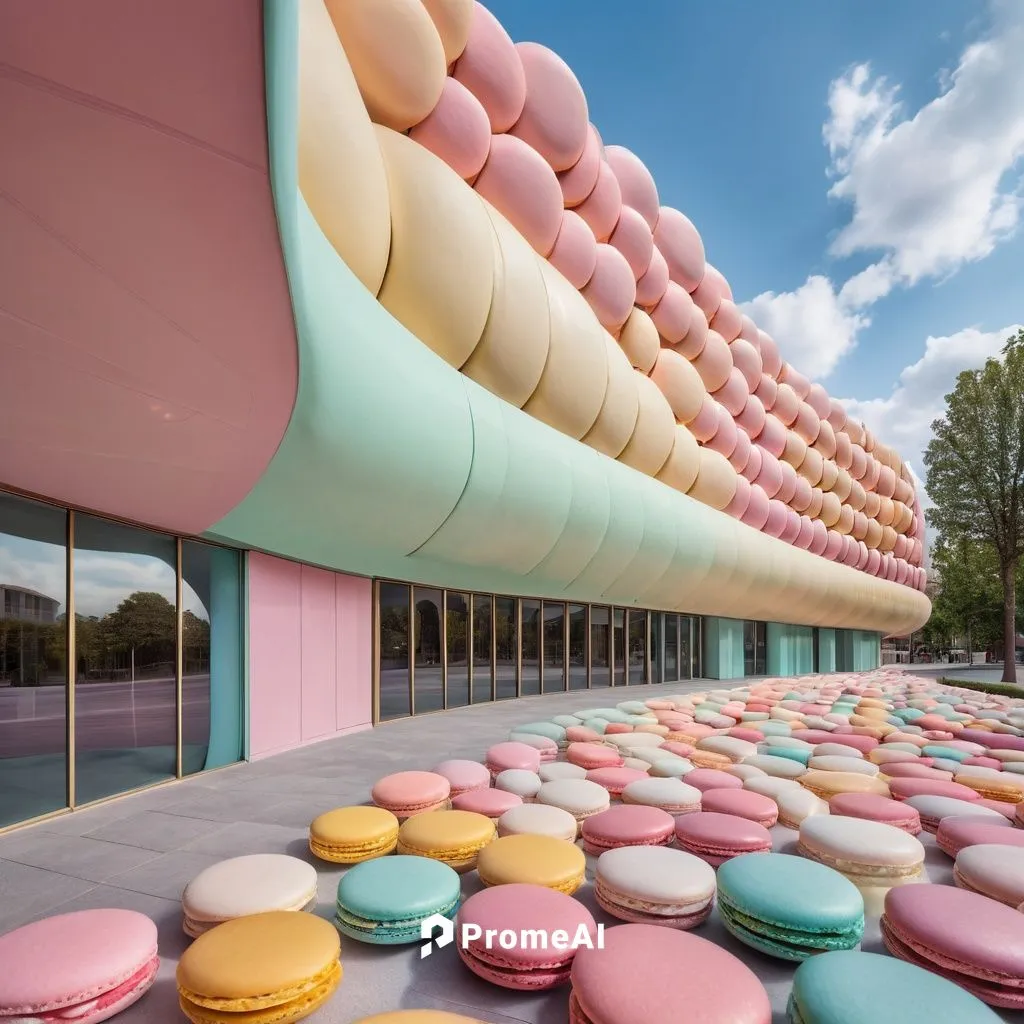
[840, 325, 1020, 498]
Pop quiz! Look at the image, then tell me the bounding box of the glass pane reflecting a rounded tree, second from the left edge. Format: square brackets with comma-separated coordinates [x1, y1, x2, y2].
[75, 515, 177, 804]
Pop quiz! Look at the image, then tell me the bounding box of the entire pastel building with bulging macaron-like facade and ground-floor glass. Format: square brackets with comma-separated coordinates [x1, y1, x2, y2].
[0, 0, 930, 827]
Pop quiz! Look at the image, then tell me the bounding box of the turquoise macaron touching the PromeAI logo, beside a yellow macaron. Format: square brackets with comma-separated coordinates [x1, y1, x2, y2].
[335, 856, 462, 945]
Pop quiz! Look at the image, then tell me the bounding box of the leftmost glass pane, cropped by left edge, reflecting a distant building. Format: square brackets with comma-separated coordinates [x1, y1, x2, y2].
[0, 495, 68, 827]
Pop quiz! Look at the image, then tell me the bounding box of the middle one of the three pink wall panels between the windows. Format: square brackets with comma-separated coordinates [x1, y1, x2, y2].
[301, 565, 338, 740]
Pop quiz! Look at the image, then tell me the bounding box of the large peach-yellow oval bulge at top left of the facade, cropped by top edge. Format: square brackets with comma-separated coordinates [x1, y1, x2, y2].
[327, 0, 447, 132]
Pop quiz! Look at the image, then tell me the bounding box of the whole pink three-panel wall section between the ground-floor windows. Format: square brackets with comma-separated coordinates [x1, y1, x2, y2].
[249, 552, 373, 759]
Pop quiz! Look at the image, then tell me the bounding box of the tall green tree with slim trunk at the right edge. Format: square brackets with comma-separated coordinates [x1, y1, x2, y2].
[925, 331, 1024, 683]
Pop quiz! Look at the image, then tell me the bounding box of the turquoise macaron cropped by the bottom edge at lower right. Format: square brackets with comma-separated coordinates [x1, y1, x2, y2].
[786, 950, 1002, 1024]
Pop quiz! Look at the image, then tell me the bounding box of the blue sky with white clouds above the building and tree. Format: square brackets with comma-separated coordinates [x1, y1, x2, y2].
[485, 0, 1024, 487]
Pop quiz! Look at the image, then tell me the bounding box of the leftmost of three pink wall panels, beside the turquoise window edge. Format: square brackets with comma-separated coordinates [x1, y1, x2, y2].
[249, 554, 302, 757]
